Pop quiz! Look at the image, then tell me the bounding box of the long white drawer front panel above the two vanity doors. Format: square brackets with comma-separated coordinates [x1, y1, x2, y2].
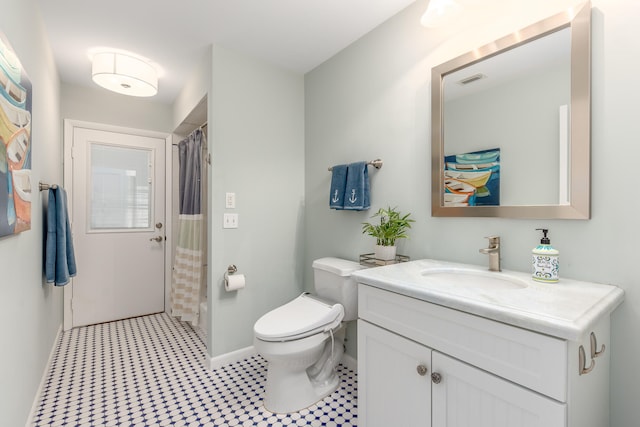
[358, 284, 568, 402]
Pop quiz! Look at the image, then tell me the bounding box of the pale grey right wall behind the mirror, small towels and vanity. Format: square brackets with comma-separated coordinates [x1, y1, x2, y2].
[304, 0, 640, 427]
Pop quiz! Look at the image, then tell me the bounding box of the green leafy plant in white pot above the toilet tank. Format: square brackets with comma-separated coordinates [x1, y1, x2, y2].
[362, 207, 415, 261]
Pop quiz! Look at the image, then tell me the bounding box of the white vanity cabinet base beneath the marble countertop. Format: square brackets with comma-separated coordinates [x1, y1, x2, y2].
[358, 283, 609, 427]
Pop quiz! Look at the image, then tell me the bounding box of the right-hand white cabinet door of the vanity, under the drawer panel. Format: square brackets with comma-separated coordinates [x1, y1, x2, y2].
[432, 351, 566, 427]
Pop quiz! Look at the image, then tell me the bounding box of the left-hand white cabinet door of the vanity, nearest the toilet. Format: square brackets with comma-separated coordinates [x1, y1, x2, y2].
[358, 320, 431, 427]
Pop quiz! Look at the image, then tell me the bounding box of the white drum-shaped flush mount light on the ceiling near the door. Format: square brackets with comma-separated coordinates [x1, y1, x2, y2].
[91, 52, 158, 96]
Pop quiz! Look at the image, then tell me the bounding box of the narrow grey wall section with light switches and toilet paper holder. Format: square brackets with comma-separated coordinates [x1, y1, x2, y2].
[208, 46, 304, 356]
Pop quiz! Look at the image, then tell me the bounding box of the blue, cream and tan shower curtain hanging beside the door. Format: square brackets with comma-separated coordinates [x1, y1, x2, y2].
[171, 129, 206, 325]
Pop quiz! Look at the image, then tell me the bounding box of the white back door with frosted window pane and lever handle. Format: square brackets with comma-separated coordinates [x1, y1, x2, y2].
[65, 126, 166, 327]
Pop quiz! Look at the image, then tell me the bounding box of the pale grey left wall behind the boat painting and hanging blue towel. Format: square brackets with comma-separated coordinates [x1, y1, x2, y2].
[0, 0, 62, 426]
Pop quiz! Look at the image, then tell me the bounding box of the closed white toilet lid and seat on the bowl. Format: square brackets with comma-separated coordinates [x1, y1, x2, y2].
[253, 293, 344, 341]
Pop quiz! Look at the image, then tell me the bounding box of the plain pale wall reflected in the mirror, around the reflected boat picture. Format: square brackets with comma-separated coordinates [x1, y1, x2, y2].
[443, 28, 571, 206]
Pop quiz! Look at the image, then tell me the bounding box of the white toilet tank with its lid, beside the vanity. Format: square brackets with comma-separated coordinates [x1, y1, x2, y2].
[312, 258, 364, 321]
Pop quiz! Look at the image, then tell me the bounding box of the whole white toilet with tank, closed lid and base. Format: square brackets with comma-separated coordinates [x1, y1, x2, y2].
[253, 258, 364, 413]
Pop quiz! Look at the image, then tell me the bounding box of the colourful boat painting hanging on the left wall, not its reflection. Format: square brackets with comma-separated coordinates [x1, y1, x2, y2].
[0, 32, 33, 237]
